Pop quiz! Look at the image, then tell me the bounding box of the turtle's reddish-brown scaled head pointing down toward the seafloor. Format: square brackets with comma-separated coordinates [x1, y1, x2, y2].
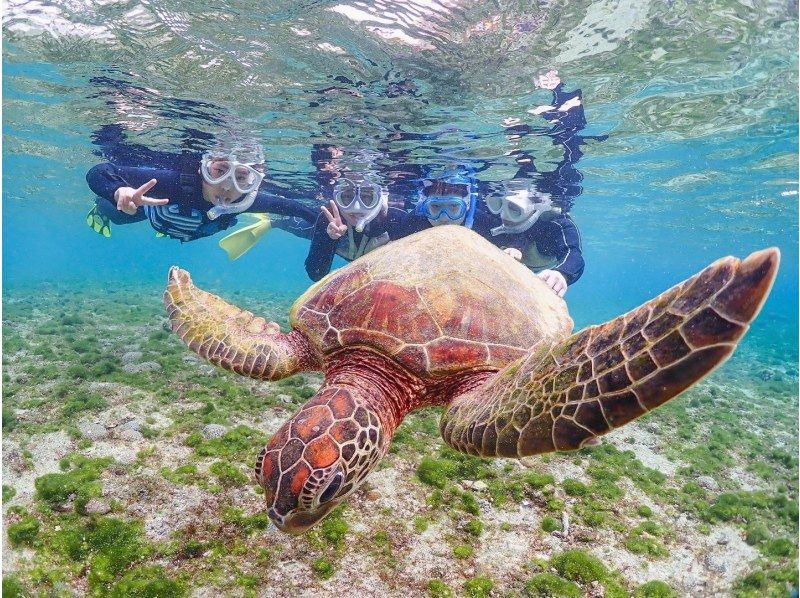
[256, 387, 391, 534]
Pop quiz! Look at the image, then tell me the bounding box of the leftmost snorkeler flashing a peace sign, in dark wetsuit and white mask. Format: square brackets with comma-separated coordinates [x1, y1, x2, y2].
[86, 137, 315, 245]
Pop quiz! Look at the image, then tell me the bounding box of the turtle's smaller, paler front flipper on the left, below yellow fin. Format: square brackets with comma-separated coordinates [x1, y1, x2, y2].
[164, 266, 320, 380]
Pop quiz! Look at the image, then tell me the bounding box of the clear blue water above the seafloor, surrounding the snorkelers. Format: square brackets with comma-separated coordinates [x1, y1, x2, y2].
[3, 3, 798, 360]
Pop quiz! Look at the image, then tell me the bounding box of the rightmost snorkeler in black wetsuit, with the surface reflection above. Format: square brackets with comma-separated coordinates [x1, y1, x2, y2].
[485, 71, 606, 297]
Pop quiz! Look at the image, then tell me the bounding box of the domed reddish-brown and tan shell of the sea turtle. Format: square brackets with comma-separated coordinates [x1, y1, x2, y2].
[291, 226, 572, 377]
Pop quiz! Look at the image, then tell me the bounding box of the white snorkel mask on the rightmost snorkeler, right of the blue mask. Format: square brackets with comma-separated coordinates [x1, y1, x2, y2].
[486, 179, 561, 236]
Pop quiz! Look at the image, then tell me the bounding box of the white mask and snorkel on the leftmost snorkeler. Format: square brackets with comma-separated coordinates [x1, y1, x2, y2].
[200, 148, 264, 220]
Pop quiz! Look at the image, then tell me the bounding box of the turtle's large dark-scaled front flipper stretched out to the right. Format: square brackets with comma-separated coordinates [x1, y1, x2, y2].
[441, 248, 780, 457]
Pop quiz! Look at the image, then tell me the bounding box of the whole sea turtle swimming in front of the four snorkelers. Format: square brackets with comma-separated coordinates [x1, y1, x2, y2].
[164, 226, 779, 533]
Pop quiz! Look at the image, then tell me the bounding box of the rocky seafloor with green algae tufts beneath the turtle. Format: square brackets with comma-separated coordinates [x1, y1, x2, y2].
[3, 287, 798, 597]
